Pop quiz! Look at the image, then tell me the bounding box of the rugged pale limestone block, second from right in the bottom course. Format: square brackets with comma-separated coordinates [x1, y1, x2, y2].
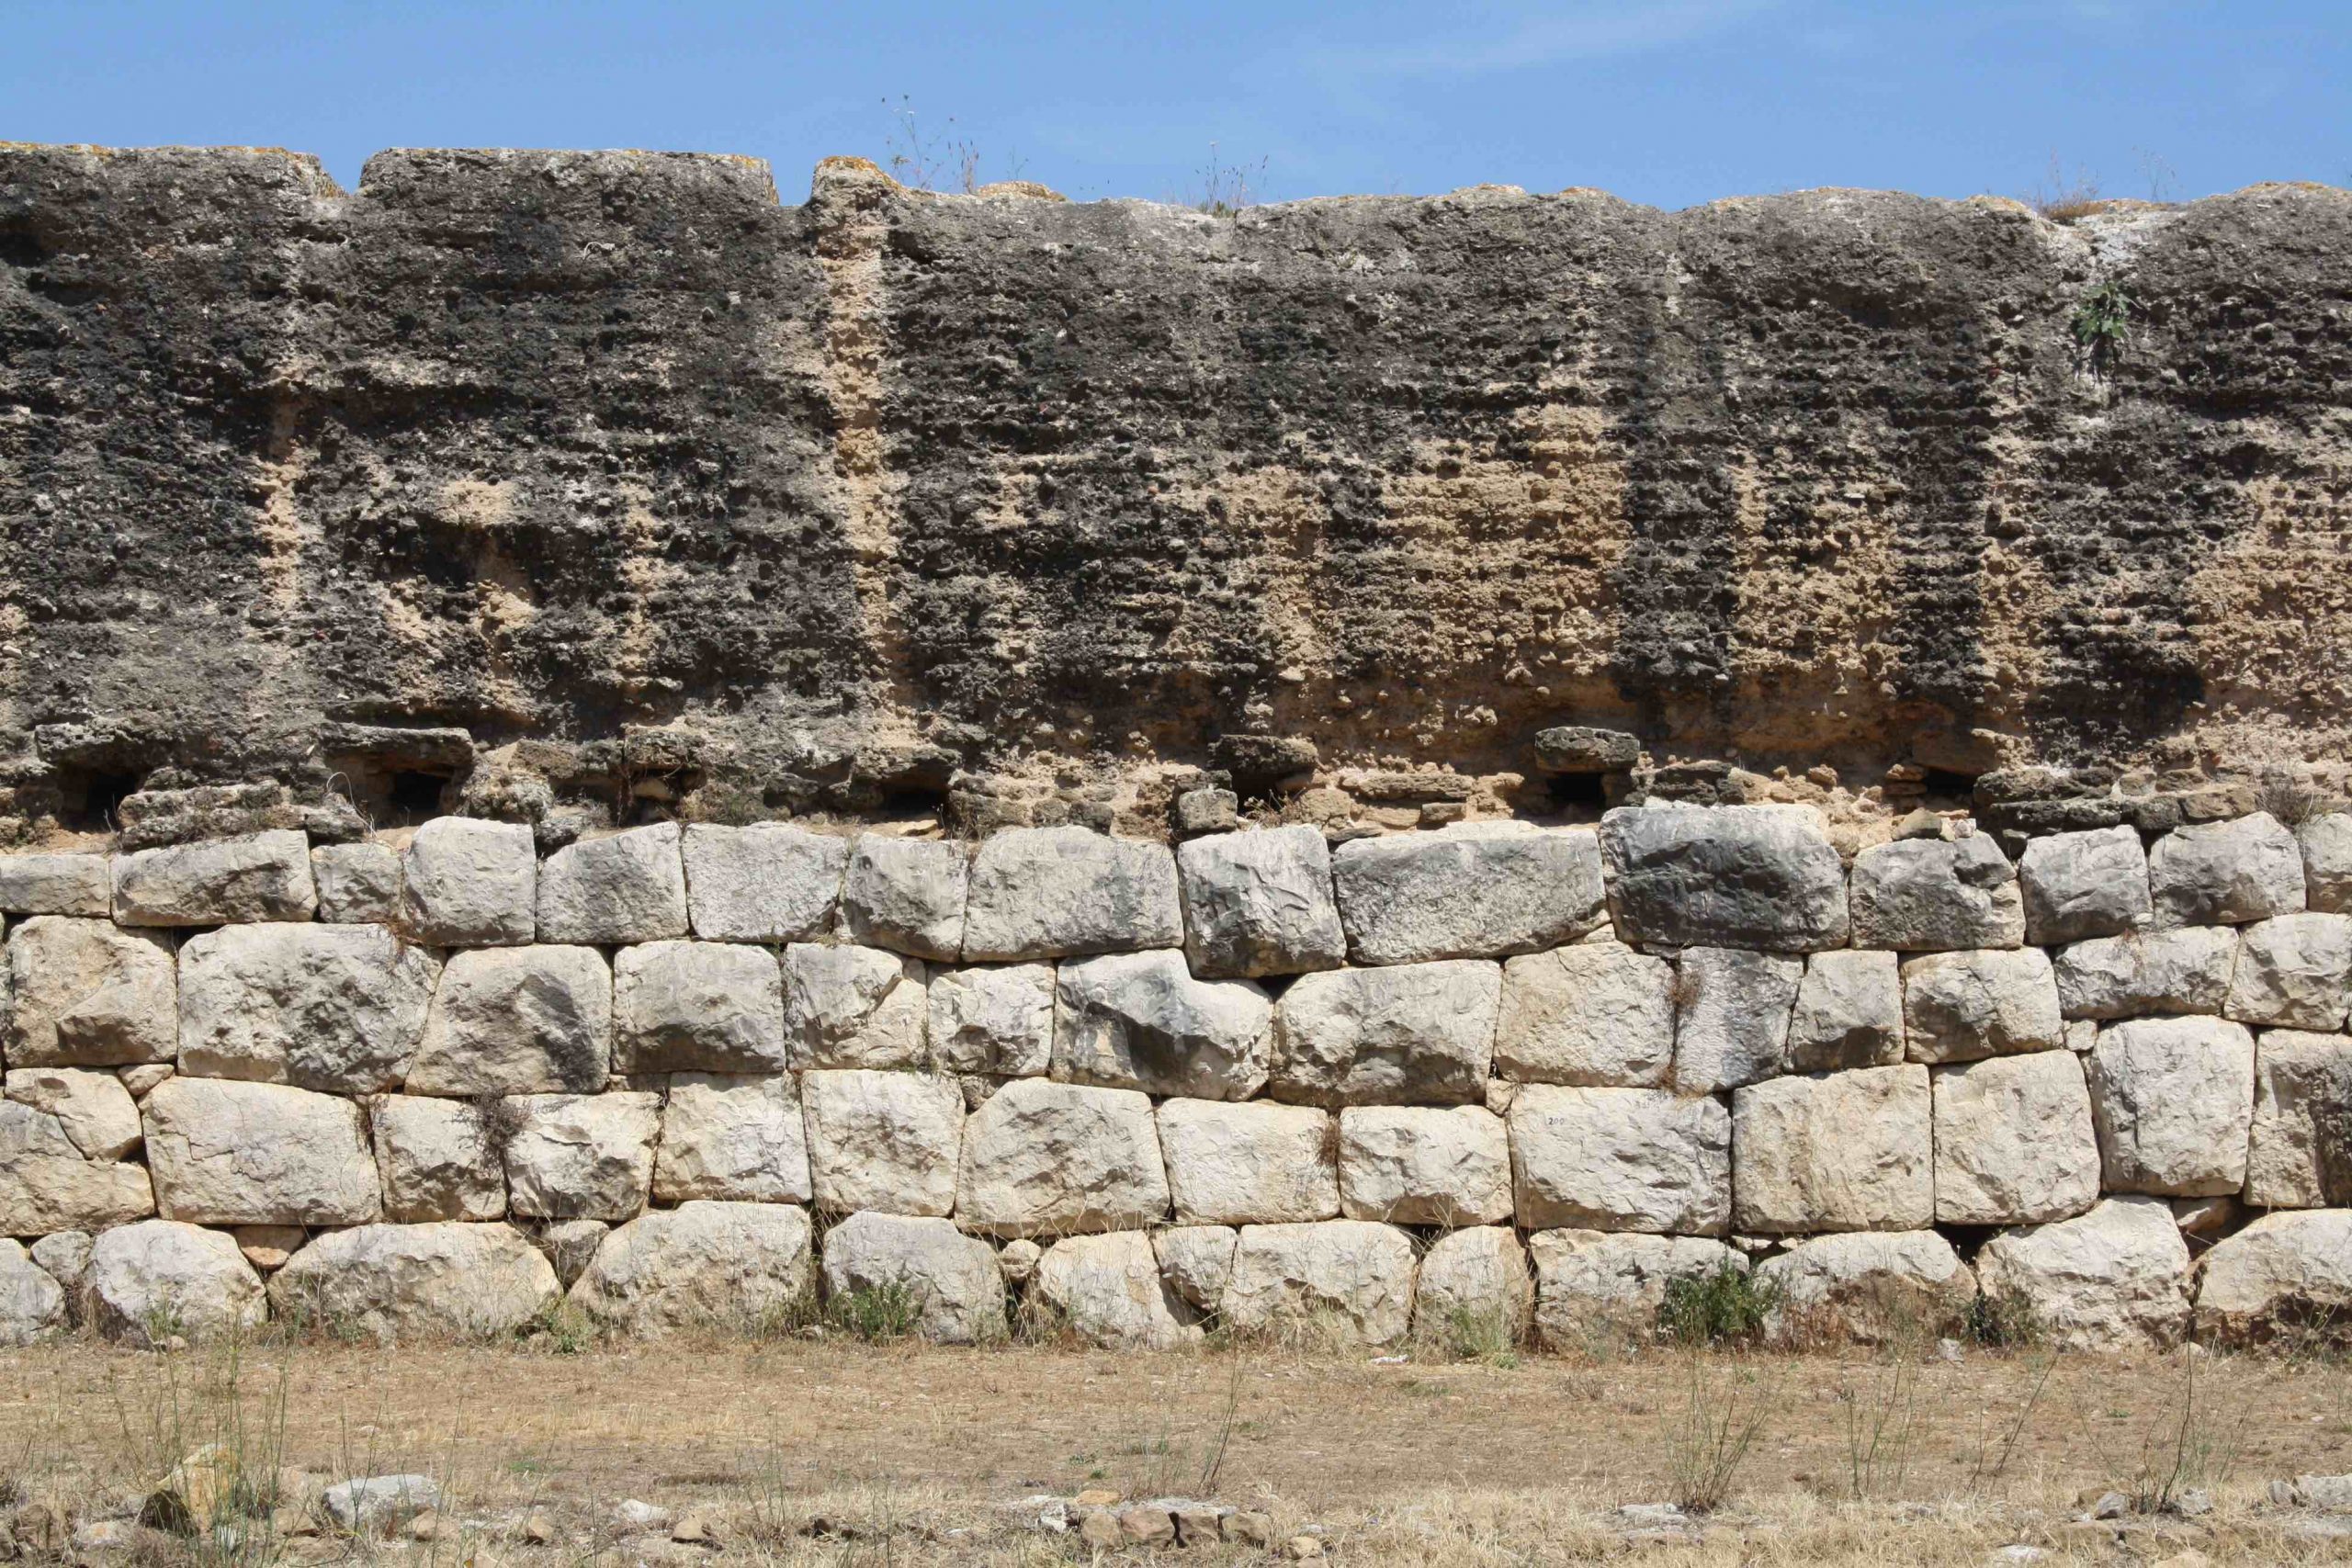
[1975, 1197, 2189, 1352]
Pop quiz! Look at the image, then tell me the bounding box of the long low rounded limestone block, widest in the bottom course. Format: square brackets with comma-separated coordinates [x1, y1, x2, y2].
[268, 1223, 562, 1342]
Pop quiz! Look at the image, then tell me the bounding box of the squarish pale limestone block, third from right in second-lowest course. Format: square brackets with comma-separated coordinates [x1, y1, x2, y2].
[1933, 1051, 2098, 1224]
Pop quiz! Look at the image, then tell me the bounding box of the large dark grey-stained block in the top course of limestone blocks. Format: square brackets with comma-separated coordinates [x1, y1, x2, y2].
[1601, 807, 1849, 952]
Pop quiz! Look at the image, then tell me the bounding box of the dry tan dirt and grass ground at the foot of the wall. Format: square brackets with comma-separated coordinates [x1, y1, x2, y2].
[14, 1340, 2352, 1568]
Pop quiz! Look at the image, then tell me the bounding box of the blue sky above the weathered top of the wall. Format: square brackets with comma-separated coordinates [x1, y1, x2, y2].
[0, 0, 2352, 207]
